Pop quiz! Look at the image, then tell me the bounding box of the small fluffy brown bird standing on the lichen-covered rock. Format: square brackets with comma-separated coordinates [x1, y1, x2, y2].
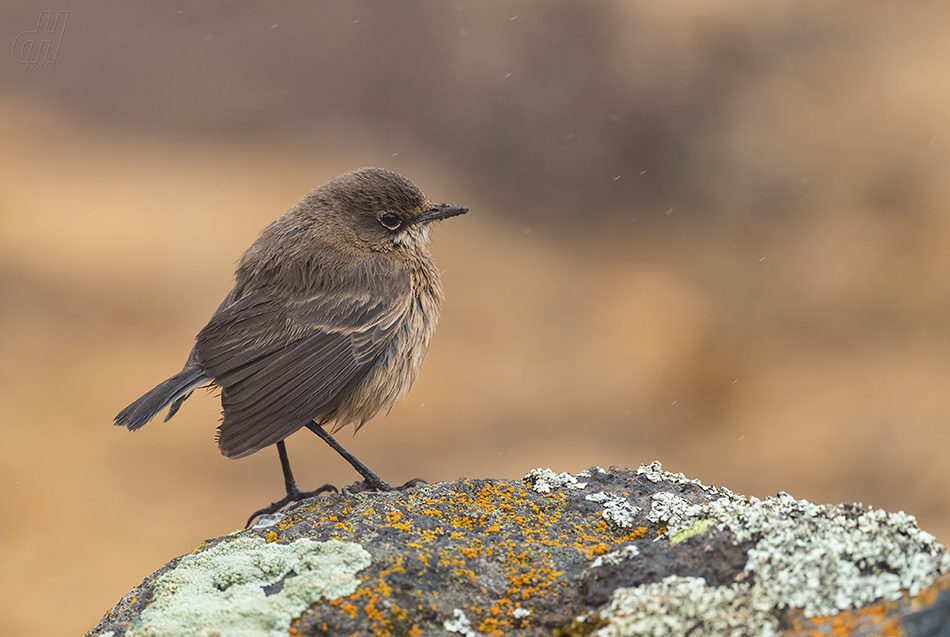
[115, 168, 468, 525]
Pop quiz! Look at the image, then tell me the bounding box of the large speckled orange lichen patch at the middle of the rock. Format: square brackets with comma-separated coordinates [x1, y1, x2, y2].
[281, 474, 668, 637]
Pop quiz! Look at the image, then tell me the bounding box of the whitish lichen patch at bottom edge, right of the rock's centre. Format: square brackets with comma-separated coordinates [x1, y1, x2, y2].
[593, 575, 778, 637]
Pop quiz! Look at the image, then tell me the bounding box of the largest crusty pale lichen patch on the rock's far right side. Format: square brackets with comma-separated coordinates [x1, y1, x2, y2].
[641, 463, 950, 617]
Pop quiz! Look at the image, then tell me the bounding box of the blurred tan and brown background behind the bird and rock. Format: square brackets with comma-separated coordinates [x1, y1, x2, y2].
[0, 0, 950, 635]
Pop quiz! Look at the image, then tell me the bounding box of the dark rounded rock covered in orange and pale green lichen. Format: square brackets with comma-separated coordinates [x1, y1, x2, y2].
[89, 463, 950, 637]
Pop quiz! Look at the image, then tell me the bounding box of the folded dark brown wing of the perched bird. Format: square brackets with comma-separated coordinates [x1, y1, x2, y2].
[195, 272, 411, 458]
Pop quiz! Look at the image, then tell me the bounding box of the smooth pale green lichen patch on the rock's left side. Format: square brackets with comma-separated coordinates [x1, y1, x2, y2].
[126, 536, 370, 637]
